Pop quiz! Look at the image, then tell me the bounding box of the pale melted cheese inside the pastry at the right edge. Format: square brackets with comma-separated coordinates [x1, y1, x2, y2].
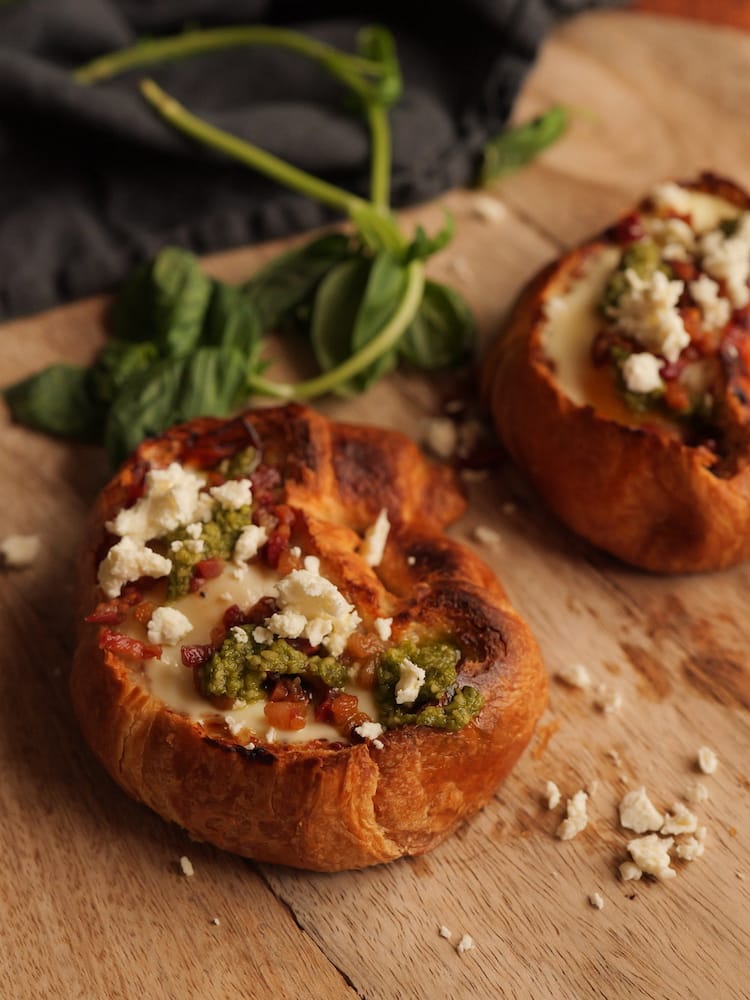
[541, 191, 740, 434]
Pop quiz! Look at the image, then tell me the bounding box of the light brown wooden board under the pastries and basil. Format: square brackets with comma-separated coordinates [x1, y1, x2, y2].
[0, 12, 750, 1000]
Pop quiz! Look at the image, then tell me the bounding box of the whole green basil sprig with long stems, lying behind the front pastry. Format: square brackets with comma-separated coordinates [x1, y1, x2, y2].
[4, 26, 475, 463]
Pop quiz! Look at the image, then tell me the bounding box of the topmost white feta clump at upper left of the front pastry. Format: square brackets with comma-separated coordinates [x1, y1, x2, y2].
[107, 462, 212, 542]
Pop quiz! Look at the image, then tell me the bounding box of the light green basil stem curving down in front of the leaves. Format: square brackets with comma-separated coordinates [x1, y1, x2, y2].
[249, 260, 425, 399]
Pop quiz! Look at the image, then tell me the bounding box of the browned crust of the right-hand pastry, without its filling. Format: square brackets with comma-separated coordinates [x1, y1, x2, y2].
[480, 172, 750, 573]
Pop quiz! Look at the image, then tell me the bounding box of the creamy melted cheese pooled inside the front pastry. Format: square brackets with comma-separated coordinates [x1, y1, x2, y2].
[129, 562, 378, 743]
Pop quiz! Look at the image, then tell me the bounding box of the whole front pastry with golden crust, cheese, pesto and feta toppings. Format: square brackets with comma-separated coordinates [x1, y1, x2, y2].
[71, 404, 546, 871]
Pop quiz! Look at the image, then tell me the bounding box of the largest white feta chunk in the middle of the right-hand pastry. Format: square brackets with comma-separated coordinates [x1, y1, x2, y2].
[609, 268, 690, 361]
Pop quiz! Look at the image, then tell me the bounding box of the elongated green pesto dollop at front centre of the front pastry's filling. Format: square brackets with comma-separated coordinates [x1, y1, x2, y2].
[198, 625, 348, 702]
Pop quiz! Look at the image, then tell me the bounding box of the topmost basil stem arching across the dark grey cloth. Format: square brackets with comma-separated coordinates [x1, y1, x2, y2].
[73, 25, 382, 96]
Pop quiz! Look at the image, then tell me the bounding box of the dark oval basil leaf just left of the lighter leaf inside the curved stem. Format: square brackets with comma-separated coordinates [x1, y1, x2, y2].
[310, 256, 371, 380]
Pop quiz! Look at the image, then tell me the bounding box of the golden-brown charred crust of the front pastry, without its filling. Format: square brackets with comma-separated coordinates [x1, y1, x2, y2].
[71, 404, 546, 871]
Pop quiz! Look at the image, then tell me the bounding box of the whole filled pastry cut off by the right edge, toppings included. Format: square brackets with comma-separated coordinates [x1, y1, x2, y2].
[482, 174, 750, 573]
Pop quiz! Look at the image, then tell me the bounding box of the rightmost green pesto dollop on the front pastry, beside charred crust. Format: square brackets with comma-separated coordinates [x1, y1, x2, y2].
[375, 641, 484, 732]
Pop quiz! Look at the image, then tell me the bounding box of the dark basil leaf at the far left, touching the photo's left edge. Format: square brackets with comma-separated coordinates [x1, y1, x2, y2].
[3, 364, 101, 441]
